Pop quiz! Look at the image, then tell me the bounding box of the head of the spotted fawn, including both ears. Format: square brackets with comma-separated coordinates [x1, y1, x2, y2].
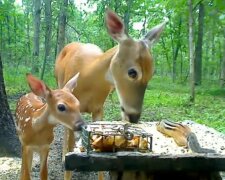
[27, 74, 84, 131]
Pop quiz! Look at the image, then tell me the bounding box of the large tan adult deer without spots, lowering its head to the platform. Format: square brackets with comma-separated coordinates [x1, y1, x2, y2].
[55, 11, 165, 180]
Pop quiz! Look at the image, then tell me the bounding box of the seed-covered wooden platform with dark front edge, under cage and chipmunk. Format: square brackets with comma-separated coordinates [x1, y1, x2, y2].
[65, 121, 225, 172]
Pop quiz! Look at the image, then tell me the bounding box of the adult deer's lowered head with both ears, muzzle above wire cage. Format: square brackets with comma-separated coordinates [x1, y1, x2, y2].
[106, 11, 165, 123]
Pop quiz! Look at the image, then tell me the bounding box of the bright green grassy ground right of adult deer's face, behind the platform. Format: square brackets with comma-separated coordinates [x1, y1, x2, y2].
[143, 78, 225, 133]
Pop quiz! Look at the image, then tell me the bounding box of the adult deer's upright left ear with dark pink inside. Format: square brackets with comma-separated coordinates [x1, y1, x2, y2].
[105, 10, 127, 42]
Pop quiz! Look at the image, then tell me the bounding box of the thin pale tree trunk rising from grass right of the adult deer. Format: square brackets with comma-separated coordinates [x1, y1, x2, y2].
[188, 0, 195, 102]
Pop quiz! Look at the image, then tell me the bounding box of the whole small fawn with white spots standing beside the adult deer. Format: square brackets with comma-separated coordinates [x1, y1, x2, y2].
[16, 74, 84, 180]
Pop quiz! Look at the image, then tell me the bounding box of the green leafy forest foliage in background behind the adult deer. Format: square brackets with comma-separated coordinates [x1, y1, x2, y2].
[0, 0, 225, 81]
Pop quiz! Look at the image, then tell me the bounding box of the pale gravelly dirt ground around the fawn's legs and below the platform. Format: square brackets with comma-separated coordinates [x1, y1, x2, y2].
[0, 125, 108, 180]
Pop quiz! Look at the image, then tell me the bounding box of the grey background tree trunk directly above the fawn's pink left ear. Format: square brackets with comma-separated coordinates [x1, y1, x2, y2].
[32, 0, 41, 73]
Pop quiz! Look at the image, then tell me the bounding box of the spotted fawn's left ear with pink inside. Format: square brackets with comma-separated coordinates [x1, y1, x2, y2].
[26, 73, 51, 98]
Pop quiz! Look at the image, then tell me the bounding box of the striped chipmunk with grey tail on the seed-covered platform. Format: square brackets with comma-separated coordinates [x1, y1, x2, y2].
[156, 120, 215, 153]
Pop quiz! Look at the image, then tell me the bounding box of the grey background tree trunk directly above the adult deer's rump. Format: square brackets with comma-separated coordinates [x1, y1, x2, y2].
[57, 0, 68, 54]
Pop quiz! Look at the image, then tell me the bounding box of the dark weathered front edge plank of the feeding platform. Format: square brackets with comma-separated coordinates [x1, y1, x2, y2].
[65, 152, 225, 172]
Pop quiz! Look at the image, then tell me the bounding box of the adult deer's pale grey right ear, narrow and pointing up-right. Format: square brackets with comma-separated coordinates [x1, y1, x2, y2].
[143, 21, 167, 47]
